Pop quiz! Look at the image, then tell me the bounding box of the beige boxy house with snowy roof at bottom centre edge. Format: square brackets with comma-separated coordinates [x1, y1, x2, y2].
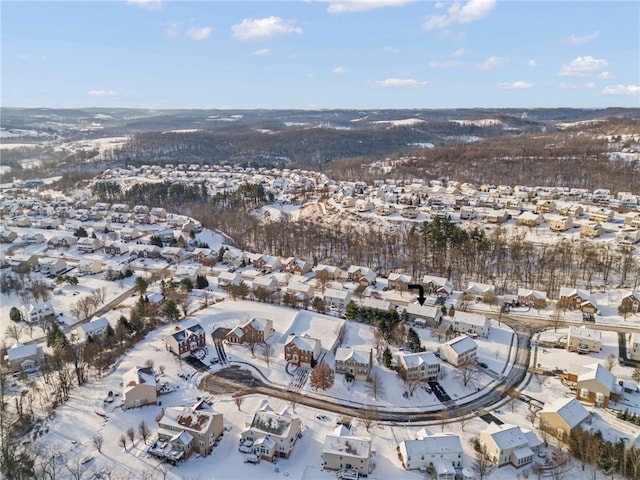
[322, 425, 371, 475]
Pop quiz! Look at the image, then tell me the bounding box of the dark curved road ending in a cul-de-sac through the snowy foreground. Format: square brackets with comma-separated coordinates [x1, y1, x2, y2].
[200, 329, 531, 423]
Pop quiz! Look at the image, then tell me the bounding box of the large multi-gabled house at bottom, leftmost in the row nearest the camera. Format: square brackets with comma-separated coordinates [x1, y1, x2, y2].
[148, 401, 224, 464]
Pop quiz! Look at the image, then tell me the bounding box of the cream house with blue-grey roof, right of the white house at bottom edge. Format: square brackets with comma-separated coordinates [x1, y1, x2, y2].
[480, 422, 541, 468]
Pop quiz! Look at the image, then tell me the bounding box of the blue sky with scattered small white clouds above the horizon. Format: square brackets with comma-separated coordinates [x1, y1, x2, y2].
[0, 0, 640, 109]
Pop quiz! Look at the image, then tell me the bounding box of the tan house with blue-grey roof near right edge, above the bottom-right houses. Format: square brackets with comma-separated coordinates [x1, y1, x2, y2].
[568, 363, 621, 408]
